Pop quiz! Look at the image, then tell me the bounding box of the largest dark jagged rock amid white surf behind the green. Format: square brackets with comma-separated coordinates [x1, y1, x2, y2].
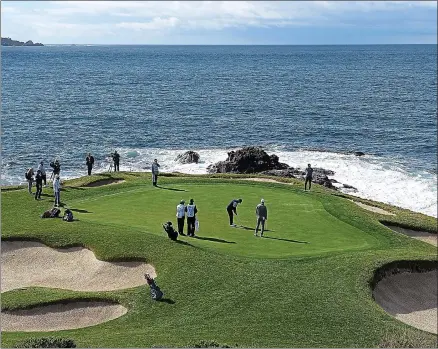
[207, 147, 289, 173]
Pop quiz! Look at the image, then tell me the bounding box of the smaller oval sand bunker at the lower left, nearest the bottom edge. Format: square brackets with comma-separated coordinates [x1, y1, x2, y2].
[1, 301, 128, 332]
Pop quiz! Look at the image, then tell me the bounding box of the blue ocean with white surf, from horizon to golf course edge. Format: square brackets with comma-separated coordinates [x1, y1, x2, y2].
[1, 45, 437, 217]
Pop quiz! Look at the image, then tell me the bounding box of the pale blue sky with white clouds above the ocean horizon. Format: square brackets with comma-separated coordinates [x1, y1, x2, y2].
[1, 0, 437, 45]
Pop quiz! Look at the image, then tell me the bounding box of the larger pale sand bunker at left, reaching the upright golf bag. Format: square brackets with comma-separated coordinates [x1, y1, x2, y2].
[1, 241, 156, 292]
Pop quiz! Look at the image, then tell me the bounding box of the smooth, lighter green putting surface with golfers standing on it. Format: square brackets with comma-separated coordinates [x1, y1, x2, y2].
[69, 183, 378, 258]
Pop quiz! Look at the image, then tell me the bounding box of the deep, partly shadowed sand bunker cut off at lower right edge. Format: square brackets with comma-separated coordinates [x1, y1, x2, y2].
[373, 270, 438, 334]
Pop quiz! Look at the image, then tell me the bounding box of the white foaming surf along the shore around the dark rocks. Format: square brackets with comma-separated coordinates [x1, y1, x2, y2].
[8, 147, 437, 217]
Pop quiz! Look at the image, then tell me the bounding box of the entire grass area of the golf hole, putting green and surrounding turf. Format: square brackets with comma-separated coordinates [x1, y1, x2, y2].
[1, 173, 436, 348]
